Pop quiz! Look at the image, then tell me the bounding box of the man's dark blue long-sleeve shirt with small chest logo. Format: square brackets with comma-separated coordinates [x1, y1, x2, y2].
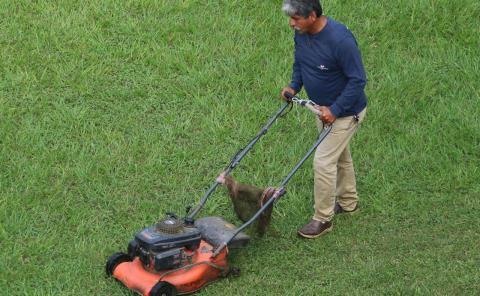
[290, 17, 367, 117]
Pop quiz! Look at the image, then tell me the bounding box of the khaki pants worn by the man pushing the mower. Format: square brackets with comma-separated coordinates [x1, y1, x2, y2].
[313, 108, 367, 222]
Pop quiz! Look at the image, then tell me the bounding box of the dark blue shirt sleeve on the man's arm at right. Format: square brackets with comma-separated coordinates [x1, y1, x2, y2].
[330, 36, 367, 117]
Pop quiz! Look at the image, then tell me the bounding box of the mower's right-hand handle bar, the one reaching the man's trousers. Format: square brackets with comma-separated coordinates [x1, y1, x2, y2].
[212, 125, 332, 257]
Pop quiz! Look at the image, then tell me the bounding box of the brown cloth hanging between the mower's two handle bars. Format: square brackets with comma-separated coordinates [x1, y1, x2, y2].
[217, 173, 275, 236]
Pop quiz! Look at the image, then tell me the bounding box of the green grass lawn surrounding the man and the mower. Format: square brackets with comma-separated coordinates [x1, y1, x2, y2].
[0, 0, 480, 295]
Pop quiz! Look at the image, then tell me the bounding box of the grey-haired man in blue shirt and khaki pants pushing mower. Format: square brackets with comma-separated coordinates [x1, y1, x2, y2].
[281, 0, 367, 238]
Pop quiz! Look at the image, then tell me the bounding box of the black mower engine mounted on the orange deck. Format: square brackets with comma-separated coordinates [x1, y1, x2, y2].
[128, 215, 202, 272]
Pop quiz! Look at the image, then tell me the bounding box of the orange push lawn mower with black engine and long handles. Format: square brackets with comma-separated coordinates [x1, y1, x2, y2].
[106, 94, 332, 296]
